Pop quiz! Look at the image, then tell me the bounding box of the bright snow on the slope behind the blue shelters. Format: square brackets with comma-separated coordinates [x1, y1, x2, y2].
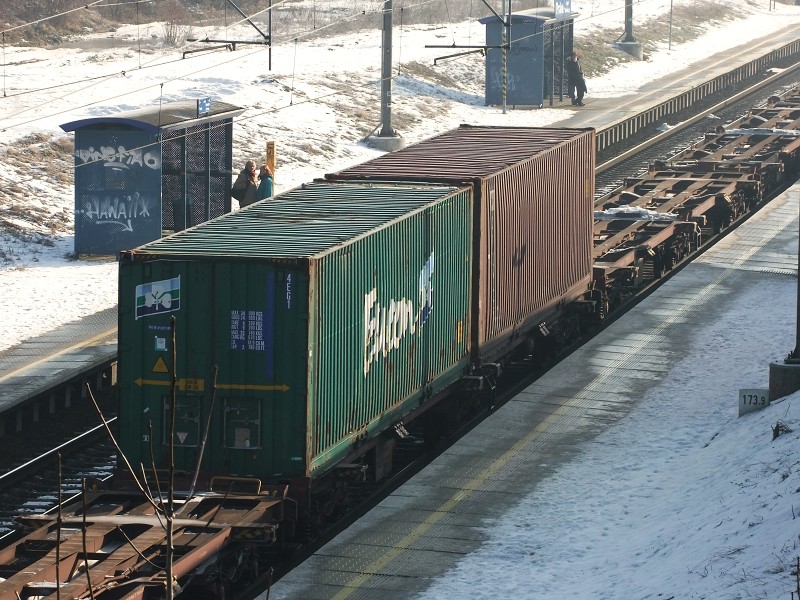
[0, 0, 800, 349]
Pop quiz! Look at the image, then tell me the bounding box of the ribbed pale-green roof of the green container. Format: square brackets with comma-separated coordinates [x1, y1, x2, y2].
[124, 182, 466, 259]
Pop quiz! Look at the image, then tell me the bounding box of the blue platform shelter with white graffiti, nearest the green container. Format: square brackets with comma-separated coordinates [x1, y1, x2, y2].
[61, 99, 244, 255]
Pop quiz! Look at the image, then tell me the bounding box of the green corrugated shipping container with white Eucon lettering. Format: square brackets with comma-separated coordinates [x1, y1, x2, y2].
[119, 183, 472, 481]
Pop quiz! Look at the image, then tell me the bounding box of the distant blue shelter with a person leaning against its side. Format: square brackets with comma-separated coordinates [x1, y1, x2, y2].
[480, 7, 574, 107]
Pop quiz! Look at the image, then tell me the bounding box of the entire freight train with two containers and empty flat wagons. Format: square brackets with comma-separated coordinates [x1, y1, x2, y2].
[0, 86, 800, 600]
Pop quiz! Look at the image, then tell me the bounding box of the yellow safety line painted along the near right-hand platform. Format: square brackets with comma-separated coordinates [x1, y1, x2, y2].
[332, 202, 796, 600]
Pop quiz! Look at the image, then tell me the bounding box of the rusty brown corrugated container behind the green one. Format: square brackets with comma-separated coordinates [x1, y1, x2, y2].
[326, 125, 595, 362]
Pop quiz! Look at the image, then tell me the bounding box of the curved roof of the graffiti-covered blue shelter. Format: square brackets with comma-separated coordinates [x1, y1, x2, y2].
[61, 100, 245, 133]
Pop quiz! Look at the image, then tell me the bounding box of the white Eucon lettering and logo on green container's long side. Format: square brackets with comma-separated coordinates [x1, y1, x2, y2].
[364, 253, 434, 377]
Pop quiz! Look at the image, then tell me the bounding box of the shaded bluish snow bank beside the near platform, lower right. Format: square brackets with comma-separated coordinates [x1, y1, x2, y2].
[417, 275, 800, 600]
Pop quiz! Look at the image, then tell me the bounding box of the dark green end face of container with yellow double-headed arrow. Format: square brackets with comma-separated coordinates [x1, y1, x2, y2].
[119, 260, 308, 478]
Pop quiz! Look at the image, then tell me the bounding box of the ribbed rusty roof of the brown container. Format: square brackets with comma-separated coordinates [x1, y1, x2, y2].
[326, 125, 592, 182]
